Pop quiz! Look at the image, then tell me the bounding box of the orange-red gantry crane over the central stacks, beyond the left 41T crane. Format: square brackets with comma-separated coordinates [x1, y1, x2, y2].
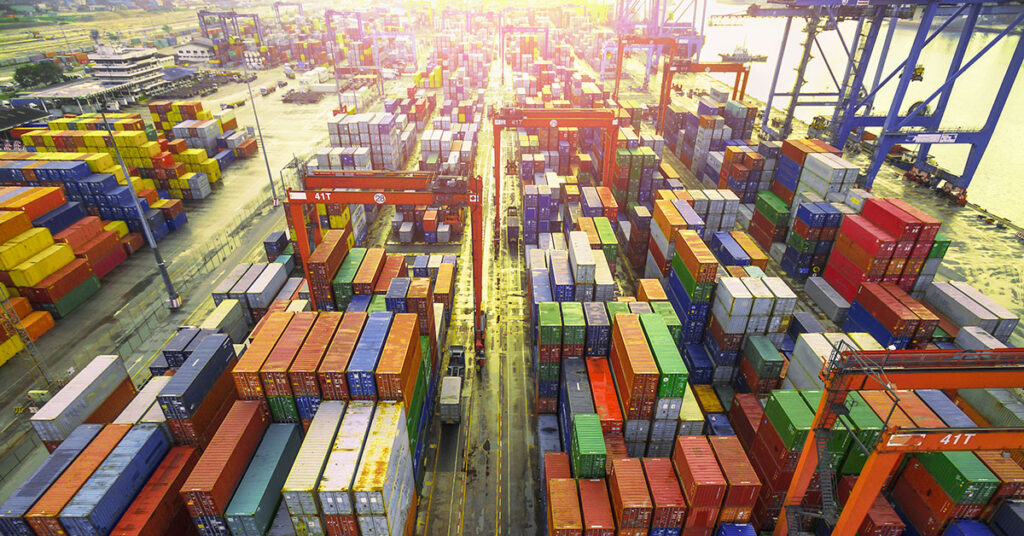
[493, 108, 618, 229]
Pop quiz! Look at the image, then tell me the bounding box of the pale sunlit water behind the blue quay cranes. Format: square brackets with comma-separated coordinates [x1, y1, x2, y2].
[701, 0, 1024, 223]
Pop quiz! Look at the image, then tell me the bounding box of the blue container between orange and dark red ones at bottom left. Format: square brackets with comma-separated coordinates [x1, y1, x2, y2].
[59, 424, 171, 536]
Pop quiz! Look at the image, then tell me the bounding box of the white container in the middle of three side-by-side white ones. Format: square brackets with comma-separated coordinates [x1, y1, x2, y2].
[317, 401, 374, 516]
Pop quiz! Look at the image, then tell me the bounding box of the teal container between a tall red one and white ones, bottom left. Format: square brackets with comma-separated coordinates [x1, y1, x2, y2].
[224, 423, 302, 536]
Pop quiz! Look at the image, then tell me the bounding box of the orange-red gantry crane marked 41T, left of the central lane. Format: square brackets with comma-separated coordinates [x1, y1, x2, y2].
[288, 170, 483, 348]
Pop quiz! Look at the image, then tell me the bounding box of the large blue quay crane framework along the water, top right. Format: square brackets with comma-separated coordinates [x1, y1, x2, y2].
[711, 0, 1024, 190]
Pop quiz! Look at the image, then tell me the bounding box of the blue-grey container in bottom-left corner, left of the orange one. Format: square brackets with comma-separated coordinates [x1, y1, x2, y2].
[0, 424, 103, 536]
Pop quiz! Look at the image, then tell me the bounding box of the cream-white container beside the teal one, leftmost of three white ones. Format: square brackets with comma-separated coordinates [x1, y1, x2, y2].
[282, 401, 345, 516]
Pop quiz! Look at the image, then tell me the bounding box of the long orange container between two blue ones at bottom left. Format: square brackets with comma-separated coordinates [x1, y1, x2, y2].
[25, 424, 131, 536]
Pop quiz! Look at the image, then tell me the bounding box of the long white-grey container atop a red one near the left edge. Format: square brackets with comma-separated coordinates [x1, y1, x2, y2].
[29, 356, 128, 442]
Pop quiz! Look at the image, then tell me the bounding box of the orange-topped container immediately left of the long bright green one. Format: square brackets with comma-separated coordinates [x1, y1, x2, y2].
[608, 314, 658, 420]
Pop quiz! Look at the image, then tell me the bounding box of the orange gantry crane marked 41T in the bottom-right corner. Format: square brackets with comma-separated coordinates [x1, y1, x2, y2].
[774, 343, 1024, 536]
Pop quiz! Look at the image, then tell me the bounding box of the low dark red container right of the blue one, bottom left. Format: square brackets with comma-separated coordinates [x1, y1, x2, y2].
[111, 447, 199, 536]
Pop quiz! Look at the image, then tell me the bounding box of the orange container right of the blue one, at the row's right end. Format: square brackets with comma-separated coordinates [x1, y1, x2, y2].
[375, 313, 423, 408]
